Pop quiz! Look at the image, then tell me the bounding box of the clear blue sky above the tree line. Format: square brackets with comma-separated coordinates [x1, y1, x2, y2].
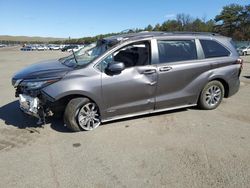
[0, 0, 249, 38]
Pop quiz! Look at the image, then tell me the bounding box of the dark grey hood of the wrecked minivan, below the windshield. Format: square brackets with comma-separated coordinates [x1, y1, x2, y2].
[12, 60, 73, 80]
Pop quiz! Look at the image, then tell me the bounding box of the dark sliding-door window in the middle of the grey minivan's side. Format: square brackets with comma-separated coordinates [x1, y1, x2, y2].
[158, 40, 197, 63]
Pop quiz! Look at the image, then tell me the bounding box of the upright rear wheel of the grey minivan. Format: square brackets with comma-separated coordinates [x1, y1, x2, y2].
[198, 80, 225, 110]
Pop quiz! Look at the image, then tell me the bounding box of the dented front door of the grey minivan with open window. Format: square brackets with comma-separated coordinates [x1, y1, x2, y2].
[99, 41, 157, 120]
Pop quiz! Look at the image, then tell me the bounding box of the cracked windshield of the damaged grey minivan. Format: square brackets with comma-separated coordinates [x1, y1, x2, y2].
[59, 42, 108, 67]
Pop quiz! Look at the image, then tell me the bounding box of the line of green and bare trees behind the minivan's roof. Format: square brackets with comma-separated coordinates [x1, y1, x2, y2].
[73, 4, 250, 43]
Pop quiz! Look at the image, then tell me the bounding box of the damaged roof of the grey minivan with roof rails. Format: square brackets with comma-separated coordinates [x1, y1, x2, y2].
[104, 31, 221, 42]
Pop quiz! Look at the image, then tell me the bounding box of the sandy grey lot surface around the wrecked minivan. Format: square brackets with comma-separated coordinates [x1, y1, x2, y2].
[0, 48, 250, 188]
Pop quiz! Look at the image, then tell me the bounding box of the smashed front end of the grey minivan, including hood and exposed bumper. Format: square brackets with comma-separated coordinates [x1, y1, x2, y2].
[11, 60, 74, 124]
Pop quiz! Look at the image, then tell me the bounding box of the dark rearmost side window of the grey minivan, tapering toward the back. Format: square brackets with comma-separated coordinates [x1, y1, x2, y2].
[200, 40, 230, 58]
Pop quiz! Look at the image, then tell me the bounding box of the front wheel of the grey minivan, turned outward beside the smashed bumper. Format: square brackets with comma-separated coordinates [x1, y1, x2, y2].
[64, 97, 101, 132]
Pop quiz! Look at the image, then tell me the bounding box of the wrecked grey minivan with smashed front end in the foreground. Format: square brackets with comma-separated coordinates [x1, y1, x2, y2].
[12, 32, 242, 131]
